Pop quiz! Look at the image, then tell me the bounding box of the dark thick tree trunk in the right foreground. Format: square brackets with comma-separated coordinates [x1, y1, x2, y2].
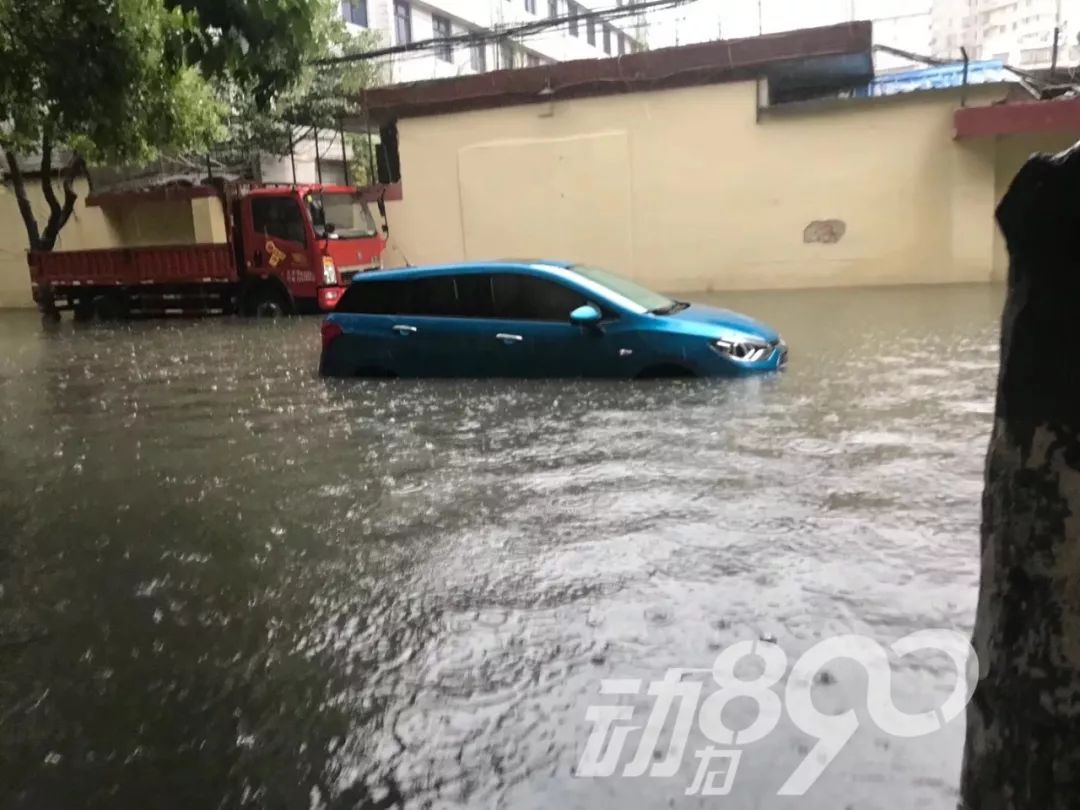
[962, 144, 1080, 810]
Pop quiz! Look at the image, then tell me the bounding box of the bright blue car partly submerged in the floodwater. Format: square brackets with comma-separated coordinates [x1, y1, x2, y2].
[320, 261, 787, 378]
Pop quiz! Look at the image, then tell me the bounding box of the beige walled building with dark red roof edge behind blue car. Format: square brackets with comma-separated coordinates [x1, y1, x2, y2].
[365, 23, 1080, 293]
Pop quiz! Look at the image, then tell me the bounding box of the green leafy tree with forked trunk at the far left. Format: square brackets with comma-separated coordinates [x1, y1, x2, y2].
[0, 0, 221, 251]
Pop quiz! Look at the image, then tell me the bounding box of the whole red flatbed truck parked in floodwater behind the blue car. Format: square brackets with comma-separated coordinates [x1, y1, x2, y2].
[29, 184, 387, 320]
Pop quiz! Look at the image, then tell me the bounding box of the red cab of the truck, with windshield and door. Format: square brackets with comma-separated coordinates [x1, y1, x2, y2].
[234, 185, 386, 314]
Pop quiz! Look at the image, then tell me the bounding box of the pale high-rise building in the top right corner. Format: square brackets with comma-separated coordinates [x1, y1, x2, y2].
[931, 0, 1080, 70]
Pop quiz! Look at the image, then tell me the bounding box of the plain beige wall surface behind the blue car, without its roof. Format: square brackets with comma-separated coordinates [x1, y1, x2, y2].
[388, 82, 1019, 292]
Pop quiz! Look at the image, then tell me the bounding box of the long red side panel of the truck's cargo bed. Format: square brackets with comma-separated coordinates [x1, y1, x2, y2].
[29, 244, 238, 287]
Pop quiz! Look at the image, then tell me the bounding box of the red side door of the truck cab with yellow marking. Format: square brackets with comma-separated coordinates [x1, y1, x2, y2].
[244, 194, 321, 299]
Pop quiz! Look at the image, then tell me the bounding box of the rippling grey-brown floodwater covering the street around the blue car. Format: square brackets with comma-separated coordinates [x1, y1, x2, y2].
[0, 287, 1001, 810]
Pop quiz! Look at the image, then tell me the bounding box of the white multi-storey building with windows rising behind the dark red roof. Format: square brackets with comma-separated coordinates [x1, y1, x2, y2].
[341, 0, 645, 83]
